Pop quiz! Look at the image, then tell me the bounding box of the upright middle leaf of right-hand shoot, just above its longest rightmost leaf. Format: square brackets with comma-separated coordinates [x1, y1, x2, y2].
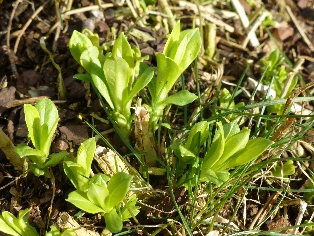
[212, 128, 250, 171]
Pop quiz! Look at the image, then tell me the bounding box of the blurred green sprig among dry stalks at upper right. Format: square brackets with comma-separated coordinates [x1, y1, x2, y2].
[262, 50, 298, 114]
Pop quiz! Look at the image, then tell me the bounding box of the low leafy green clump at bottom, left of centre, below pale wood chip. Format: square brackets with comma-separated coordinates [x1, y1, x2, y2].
[63, 138, 139, 233]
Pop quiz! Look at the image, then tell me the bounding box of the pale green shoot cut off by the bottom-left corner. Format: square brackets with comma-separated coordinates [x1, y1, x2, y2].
[0, 208, 38, 236]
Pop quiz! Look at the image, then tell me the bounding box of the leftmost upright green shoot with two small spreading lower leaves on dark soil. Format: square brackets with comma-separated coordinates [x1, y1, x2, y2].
[15, 98, 68, 177]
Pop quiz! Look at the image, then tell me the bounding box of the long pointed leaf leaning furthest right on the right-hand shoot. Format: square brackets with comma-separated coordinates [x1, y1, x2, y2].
[220, 138, 274, 169]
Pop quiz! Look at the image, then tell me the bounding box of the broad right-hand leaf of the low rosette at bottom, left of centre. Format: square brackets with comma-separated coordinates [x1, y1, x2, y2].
[105, 172, 132, 211]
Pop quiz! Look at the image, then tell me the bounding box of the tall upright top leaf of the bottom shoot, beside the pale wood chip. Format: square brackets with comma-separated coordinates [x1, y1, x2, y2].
[76, 138, 96, 177]
